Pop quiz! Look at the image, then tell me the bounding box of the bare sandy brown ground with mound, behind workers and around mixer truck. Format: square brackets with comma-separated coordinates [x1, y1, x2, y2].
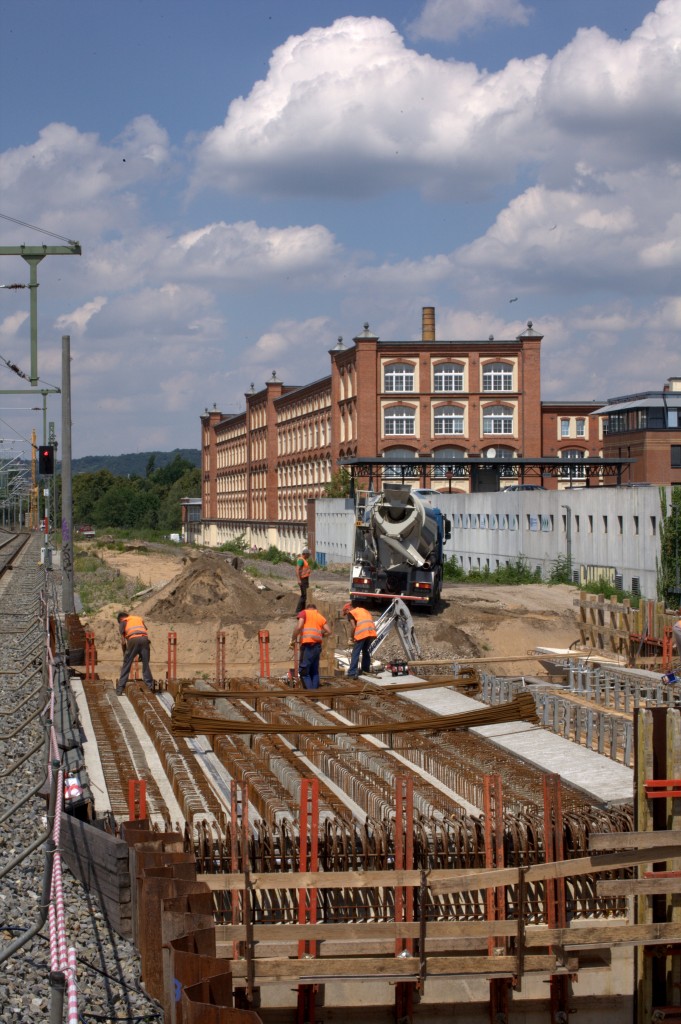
[78, 544, 579, 679]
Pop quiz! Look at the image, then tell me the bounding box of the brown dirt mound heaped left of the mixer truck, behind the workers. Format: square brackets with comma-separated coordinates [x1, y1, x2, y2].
[135, 553, 296, 625]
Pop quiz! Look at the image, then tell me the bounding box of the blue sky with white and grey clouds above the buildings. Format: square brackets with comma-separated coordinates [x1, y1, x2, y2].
[0, 0, 681, 458]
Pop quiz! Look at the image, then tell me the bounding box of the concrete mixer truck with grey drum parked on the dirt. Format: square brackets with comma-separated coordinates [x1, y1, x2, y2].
[350, 484, 451, 611]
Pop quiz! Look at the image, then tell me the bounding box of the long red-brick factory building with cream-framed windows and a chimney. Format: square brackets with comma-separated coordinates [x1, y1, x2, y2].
[201, 307, 600, 551]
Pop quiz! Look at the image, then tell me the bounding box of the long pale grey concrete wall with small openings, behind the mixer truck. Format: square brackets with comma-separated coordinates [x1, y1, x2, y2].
[315, 486, 670, 598]
